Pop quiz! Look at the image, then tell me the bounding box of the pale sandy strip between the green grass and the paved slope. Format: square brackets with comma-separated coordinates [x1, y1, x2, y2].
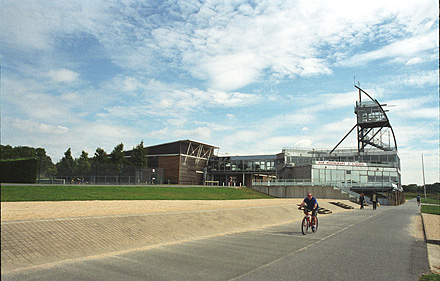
[1, 198, 356, 221]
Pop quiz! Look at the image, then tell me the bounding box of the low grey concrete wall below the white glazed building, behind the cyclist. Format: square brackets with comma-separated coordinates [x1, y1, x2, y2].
[251, 186, 350, 200]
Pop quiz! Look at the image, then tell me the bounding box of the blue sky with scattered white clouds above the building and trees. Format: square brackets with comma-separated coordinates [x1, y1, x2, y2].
[0, 0, 439, 185]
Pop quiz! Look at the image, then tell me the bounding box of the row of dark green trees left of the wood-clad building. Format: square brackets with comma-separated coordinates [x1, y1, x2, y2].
[0, 141, 147, 182]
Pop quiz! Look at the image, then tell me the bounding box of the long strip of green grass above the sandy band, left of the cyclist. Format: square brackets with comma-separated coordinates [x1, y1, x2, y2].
[1, 184, 273, 202]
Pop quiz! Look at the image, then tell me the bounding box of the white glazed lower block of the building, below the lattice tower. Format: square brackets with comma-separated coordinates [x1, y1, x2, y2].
[277, 148, 401, 190]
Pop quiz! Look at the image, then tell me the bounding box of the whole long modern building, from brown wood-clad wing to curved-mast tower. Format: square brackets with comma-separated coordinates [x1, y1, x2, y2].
[124, 86, 402, 203]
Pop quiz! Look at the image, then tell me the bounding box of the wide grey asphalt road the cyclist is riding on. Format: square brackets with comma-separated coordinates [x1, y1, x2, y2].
[1, 202, 429, 281]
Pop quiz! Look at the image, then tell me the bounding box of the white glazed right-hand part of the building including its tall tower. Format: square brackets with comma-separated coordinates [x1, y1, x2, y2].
[253, 86, 403, 204]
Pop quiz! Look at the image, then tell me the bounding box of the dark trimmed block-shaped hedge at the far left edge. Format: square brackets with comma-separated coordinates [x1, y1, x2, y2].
[0, 158, 38, 183]
